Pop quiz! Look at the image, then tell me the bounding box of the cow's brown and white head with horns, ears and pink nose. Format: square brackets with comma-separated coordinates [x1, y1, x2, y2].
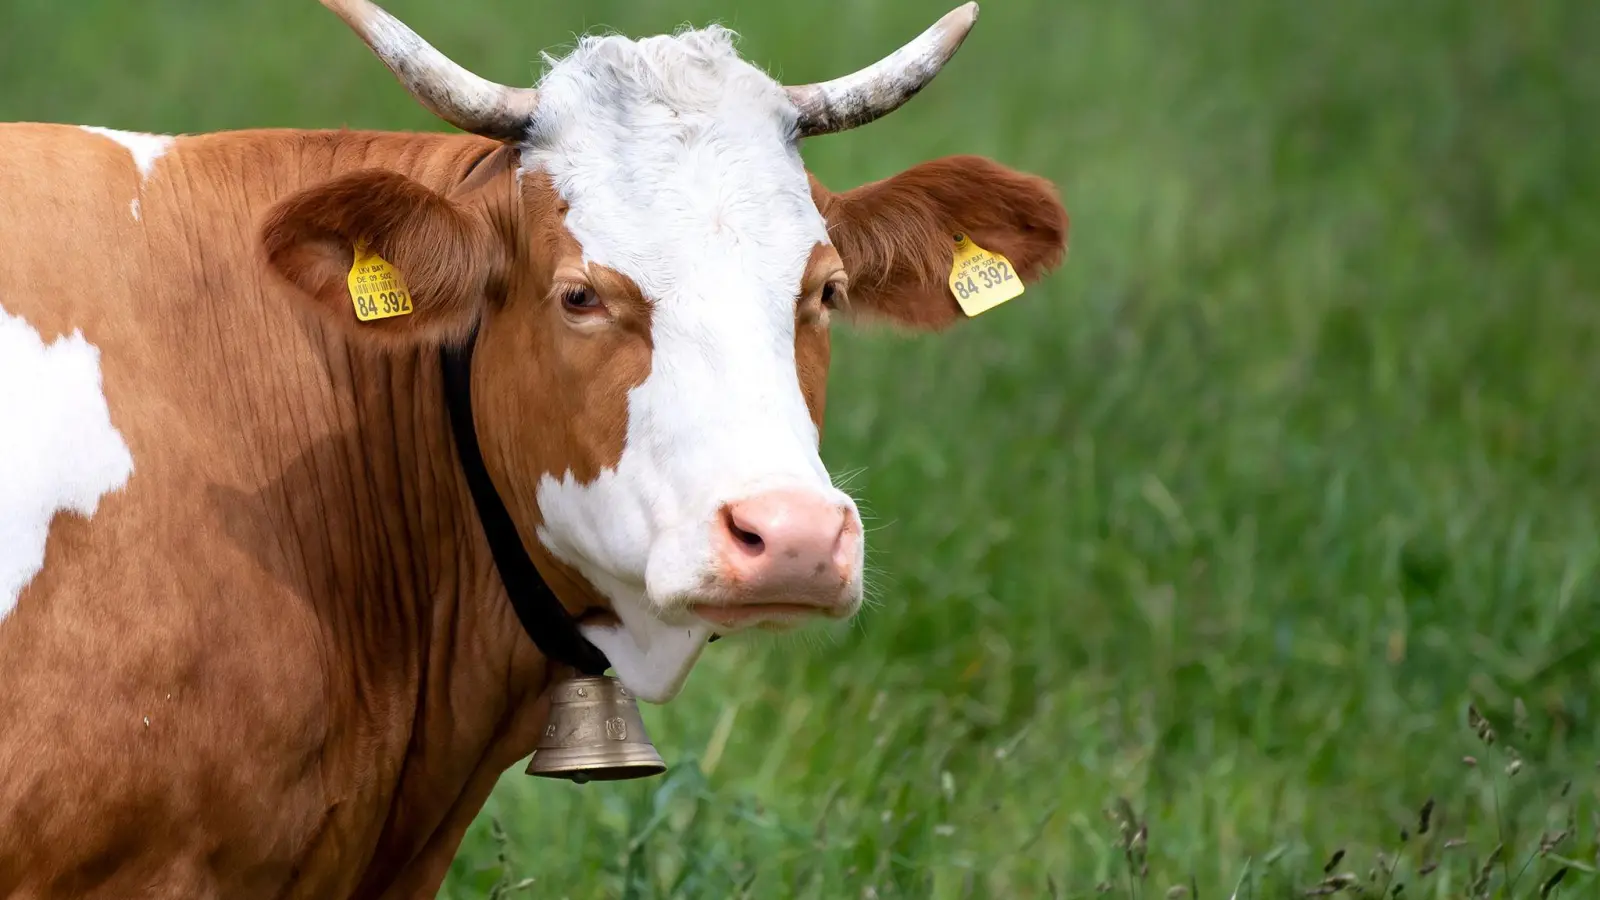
[264, 0, 1067, 701]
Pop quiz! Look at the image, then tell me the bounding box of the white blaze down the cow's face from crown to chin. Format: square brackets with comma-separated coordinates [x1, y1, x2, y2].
[523, 27, 859, 701]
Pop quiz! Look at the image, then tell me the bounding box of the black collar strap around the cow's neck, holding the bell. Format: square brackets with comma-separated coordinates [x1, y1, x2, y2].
[440, 327, 611, 676]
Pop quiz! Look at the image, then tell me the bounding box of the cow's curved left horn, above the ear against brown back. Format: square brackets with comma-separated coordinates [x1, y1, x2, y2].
[322, 0, 539, 141]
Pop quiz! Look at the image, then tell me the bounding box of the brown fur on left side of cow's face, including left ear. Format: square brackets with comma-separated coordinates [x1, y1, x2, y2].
[261, 147, 650, 615]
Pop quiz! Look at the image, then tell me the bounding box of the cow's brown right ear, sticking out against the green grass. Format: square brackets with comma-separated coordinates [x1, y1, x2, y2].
[811, 155, 1067, 330]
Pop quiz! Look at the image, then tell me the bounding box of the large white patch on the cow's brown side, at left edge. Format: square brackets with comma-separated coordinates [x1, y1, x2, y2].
[0, 301, 133, 620]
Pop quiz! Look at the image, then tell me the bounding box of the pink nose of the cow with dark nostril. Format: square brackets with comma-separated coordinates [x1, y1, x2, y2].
[715, 490, 861, 607]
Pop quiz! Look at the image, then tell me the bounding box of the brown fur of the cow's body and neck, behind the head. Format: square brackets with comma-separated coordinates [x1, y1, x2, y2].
[0, 125, 563, 898]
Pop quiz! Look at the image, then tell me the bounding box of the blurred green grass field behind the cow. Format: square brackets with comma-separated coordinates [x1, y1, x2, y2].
[0, 0, 1600, 900]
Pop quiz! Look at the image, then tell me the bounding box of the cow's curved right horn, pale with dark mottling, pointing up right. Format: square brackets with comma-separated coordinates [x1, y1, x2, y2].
[784, 3, 978, 138]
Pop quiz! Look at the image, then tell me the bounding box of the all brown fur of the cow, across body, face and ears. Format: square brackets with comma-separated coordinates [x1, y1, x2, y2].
[0, 115, 1066, 900]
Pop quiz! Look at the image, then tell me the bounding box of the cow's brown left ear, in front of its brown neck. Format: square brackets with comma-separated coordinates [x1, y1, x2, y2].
[261, 170, 499, 346]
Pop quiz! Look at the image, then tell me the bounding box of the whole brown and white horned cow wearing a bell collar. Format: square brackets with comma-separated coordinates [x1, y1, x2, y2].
[0, 0, 1067, 900]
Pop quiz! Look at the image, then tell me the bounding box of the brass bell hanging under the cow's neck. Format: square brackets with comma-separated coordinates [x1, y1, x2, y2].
[528, 676, 667, 785]
